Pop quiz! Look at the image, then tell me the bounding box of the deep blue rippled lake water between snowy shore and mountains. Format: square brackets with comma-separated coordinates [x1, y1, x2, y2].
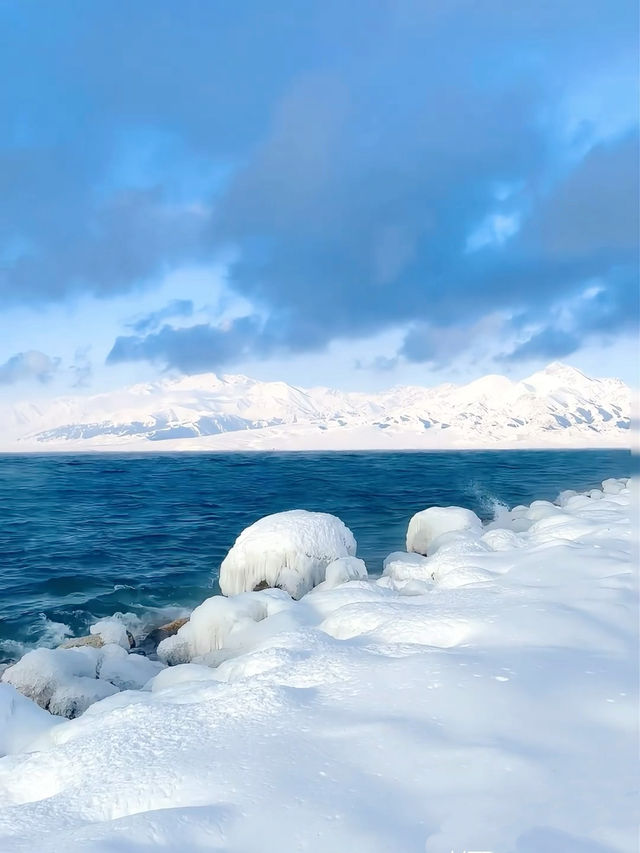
[0, 450, 636, 663]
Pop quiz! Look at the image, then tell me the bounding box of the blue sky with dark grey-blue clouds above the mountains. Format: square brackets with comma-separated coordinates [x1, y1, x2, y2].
[0, 0, 639, 401]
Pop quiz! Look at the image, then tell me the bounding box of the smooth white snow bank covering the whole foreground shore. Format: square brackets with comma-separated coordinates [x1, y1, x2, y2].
[0, 481, 639, 853]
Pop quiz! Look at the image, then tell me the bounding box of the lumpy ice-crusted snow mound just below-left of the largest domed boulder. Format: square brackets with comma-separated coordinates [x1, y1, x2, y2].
[158, 589, 292, 666]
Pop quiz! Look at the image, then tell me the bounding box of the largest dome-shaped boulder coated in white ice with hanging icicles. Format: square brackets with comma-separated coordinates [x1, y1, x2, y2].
[220, 509, 356, 599]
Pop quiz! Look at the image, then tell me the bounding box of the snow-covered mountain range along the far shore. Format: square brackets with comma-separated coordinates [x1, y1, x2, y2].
[0, 363, 631, 451]
